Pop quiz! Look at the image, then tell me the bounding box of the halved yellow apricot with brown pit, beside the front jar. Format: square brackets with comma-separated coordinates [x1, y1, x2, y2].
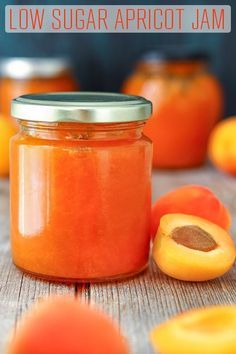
[153, 214, 235, 281]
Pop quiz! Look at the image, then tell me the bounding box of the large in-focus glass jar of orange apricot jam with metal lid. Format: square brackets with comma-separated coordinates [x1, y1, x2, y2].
[11, 92, 152, 281]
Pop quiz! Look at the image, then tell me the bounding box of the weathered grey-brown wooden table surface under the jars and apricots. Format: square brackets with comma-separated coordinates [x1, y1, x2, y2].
[0, 167, 236, 354]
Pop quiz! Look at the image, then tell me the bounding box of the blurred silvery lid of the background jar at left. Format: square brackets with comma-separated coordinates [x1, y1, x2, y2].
[0, 57, 71, 80]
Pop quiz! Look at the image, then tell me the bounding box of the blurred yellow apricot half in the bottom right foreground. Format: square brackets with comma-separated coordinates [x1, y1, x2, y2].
[150, 305, 236, 354]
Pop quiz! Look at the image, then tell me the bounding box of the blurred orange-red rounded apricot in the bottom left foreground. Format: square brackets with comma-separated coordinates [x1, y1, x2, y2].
[8, 297, 129, 354]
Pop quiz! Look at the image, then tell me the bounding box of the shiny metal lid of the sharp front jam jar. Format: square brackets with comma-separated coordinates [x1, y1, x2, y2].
[11, 92, 152, 123]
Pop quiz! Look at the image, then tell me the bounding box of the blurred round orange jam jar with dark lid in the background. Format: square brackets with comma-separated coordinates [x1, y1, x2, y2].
[122, 52, 223, 168]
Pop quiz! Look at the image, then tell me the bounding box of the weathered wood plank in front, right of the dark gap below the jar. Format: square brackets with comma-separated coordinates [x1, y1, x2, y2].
[90, 263, 236, 354]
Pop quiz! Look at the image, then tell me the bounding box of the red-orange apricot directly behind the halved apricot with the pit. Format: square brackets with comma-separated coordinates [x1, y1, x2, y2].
[151, 185, 231, 237]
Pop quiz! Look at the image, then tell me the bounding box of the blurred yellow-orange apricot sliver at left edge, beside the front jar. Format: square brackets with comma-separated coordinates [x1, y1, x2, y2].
[0, 116, 16, 177]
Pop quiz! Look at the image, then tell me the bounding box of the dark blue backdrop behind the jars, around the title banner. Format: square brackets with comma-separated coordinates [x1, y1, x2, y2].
[0, 0, 236, 115]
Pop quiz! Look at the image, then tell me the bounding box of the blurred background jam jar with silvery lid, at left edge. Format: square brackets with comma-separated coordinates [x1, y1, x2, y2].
[0, 58, 78, 121]
